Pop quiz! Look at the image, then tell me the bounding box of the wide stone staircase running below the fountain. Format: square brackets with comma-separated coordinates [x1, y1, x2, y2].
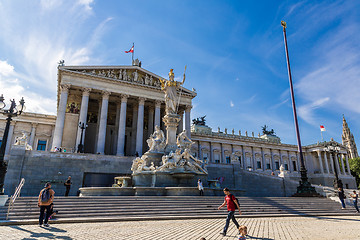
[0, 196, 355, 225]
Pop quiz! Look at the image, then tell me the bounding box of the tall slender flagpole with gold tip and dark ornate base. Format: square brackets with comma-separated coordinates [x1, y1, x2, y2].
[281, 21, 317, 196]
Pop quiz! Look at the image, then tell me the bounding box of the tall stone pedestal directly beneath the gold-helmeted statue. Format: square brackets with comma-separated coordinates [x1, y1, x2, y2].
[163, 114, 181, 154]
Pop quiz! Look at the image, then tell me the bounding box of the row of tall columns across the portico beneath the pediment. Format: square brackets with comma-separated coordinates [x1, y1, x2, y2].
[52, 84, 191, 156]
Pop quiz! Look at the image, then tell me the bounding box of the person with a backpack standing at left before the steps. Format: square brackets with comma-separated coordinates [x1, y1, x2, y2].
[38, 182, 55, 227]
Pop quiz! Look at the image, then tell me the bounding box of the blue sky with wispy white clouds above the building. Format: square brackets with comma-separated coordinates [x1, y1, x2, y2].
[0, 0, 360, 145]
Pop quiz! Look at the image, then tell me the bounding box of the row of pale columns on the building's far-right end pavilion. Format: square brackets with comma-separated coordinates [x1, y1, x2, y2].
[317, 151, 351, 175]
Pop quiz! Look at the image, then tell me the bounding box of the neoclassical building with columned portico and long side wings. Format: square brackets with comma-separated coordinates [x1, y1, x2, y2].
[0, 61, 357, 188]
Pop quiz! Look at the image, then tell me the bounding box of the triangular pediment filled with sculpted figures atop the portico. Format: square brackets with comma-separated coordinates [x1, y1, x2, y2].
[59, 66, 196, 97]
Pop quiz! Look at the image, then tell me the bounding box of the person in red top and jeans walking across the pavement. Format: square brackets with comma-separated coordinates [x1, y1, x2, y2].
[218, 188, 241, 236]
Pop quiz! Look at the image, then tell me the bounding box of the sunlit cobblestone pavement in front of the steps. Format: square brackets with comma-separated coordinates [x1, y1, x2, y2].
[0, 216, 360, 240]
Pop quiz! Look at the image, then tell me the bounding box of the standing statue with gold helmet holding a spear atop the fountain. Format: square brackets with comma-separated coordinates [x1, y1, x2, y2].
[159, 67, 186, 114]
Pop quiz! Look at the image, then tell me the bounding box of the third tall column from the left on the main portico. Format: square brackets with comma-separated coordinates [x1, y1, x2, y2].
[96, 91, 110, 154]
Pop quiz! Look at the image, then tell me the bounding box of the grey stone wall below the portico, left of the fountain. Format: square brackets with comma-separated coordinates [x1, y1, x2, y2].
[5, 146, 133, 196]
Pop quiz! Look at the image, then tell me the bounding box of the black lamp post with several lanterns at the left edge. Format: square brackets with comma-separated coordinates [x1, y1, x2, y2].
[0, 94, 25, 195]
